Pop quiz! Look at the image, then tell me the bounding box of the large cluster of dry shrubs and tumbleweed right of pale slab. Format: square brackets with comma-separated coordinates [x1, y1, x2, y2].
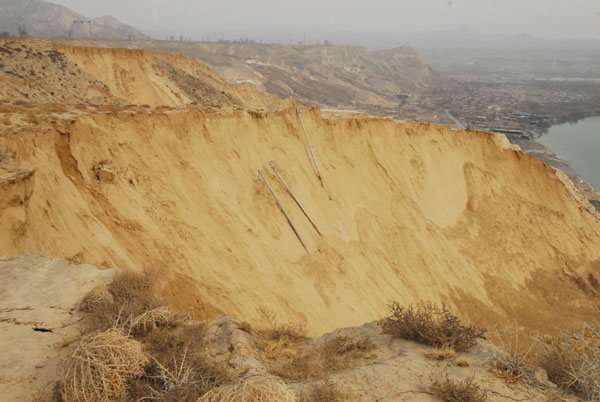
[62, 271, 229, 402]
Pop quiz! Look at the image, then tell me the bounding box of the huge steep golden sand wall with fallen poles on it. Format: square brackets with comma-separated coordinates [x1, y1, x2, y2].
[0, 109, 600, 333]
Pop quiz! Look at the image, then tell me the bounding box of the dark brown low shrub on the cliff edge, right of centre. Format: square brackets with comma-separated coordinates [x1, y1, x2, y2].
[382, 302, 485, 352]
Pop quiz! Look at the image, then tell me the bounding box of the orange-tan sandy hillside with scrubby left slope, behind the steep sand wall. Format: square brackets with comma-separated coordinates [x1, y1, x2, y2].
[0, 39, 290, 110]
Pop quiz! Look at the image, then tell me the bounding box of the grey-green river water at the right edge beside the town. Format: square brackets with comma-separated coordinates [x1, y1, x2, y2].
[537, 117, 600, 191]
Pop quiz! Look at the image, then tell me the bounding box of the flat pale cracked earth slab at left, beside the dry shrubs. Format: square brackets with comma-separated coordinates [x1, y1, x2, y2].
[0, 256, 114, 401]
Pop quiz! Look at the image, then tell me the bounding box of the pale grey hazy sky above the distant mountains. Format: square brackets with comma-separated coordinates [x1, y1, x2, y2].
[53, 0, 600, 40]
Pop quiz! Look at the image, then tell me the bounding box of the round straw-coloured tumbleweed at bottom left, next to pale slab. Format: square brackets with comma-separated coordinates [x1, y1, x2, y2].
[63, 329, 148, 402]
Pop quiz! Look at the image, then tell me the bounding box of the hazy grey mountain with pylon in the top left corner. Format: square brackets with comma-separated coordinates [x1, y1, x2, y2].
[0, 0, 148, 39]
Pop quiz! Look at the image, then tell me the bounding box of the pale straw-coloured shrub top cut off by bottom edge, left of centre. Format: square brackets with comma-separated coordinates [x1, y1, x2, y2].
[198, 375, 297, 402]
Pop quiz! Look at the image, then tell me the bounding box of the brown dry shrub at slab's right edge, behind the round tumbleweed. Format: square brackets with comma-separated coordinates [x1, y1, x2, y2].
[80, 271, 161, 330]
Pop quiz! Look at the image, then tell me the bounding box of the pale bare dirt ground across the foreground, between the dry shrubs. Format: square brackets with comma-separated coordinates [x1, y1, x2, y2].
[0, 256, 576, 401]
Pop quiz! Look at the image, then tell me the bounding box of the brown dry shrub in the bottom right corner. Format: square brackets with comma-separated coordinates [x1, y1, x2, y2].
[539, 325, 600, 401]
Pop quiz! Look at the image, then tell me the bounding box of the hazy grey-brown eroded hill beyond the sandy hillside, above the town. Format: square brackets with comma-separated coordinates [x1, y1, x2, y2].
[90, 41, 456, 118]
